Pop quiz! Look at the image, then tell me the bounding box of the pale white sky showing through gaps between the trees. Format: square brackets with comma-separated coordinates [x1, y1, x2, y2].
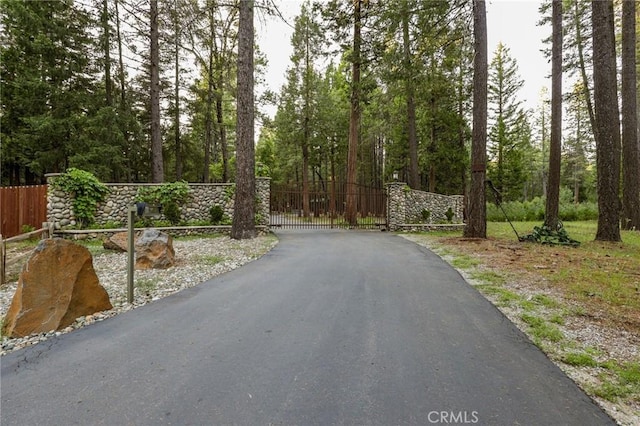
[256, 0, 551, 115]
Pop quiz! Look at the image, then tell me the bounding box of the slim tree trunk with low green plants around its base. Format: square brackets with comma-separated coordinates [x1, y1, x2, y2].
[544, 0, 562, 230]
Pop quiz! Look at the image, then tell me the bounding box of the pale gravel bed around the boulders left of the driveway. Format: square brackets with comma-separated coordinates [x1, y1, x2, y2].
[0, 234, 277, 355]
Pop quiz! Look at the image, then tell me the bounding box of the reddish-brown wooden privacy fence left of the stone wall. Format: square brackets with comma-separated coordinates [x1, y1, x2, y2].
[0, 185, 47, 238]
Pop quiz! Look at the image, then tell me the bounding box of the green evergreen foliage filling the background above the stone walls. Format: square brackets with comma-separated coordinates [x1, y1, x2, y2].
[0, 0, 640, 240]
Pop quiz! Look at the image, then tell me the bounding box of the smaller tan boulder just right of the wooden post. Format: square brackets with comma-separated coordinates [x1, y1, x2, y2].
[136, 229, 176, 269]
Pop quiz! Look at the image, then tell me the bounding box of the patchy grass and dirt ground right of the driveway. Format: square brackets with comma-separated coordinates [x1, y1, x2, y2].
[404, 222, 640, 425]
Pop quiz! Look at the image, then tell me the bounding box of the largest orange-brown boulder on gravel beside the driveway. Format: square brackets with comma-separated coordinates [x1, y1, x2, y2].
[3, 238, 112, 337]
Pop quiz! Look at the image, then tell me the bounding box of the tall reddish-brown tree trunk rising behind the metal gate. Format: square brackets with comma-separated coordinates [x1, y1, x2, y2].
[345, 0, 362, 226]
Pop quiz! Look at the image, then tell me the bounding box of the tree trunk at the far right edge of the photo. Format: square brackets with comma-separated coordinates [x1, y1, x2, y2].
[622, 1, 640, 230]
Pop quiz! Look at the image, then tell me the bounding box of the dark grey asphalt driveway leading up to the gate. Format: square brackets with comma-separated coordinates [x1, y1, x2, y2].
[0, 231, 613, 426]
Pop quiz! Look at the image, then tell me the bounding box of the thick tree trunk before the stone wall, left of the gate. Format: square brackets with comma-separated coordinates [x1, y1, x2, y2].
[231, 0, 256, 240]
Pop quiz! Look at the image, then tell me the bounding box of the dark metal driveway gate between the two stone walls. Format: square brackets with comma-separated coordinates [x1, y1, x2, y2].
[271, 183, 387, 229]
